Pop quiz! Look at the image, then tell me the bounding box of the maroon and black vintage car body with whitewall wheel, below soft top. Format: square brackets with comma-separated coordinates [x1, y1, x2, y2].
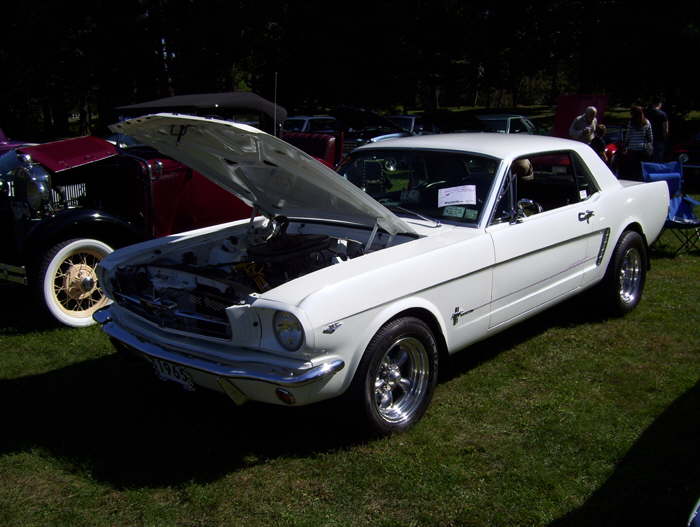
[0, 137, 250, 327]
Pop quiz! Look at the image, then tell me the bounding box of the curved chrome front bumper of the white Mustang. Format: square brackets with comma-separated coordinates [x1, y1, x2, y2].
[93, 306, 345, 388]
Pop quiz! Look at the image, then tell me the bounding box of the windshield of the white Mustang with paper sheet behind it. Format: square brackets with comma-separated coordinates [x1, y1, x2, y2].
[338, 149, 499, 224]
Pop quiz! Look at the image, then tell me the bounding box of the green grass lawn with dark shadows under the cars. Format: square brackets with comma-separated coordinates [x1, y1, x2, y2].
[0, 233, 700, 527]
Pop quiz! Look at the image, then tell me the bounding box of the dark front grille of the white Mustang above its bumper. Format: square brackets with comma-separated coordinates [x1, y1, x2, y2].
[114, 293, 231, 339]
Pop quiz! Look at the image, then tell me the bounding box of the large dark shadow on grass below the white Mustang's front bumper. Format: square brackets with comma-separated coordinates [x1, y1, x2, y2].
[0, 354, 367, 488]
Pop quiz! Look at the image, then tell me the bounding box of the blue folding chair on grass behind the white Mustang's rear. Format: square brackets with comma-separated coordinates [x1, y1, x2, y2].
[642, 161, 700, 256]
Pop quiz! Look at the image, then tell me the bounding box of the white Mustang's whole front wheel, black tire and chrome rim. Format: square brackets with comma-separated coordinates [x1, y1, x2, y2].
[351, 317, 438, 435]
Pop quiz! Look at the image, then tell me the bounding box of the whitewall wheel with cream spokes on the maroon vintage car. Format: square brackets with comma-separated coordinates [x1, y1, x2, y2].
[34, 238, 113, 327]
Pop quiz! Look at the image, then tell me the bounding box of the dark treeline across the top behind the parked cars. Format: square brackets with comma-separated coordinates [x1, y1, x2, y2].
[0, 0, 700, 140]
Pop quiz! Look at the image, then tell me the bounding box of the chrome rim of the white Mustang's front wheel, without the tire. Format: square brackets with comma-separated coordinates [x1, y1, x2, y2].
[374, 337, 430, 423]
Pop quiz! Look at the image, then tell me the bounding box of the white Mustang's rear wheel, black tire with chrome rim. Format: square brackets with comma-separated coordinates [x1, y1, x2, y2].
[601, 231, 647, 316]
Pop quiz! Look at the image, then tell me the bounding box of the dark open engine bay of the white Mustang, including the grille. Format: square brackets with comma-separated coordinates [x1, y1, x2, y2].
[112, 217, 376, 336]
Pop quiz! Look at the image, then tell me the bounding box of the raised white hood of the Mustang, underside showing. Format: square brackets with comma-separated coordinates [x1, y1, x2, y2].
[110, 113, 414, 234]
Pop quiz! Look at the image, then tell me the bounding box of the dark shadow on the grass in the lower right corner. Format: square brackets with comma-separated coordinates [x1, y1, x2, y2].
[550, 383, 700, 527]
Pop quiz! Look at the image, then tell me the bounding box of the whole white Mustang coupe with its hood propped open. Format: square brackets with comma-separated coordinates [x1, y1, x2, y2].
[95, 114, 668, 434]
